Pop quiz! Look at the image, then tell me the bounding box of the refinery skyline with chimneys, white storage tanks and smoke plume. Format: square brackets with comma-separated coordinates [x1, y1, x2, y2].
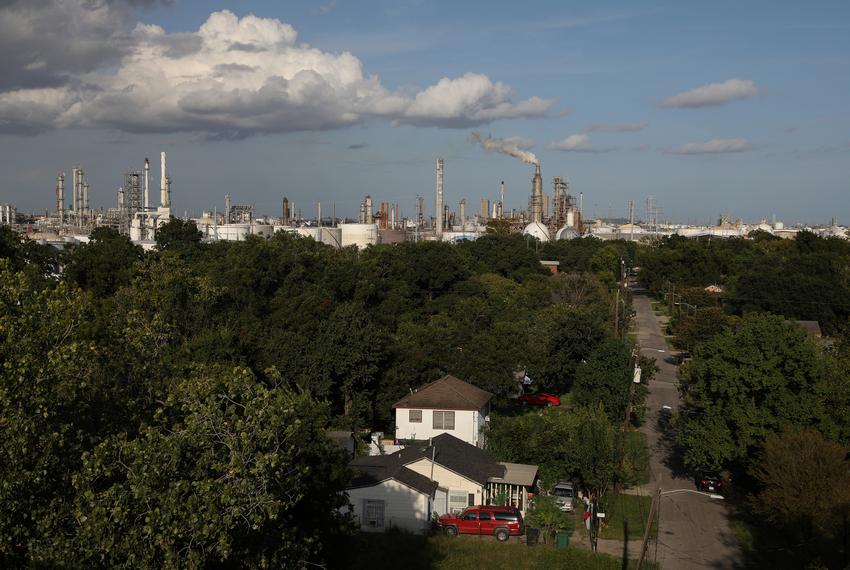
[0, 151, 847, 249]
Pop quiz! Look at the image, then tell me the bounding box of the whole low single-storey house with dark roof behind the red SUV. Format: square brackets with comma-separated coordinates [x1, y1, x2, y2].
[347, 433, 537, 531]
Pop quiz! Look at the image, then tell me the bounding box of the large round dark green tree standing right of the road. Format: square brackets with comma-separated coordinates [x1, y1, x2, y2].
[678, 313, 835, 467]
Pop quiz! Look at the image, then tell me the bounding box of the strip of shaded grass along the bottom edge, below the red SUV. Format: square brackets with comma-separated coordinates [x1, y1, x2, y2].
[348, 532, 652, 570]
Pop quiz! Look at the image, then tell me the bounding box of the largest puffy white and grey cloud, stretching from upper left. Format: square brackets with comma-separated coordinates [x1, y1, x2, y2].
[0, 4, 554, 133]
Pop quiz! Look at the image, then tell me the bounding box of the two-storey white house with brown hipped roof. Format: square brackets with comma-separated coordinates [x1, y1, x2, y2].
[393, 375, 493, 447]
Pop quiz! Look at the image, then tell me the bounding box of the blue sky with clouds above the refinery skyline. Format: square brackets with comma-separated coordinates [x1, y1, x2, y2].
[0, 0, 850, 224]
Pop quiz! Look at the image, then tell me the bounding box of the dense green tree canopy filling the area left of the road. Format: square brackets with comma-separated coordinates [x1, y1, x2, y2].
[0, 225, 627, 568]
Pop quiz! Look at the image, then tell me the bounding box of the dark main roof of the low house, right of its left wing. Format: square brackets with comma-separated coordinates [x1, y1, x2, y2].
[393, 433, 505, 485]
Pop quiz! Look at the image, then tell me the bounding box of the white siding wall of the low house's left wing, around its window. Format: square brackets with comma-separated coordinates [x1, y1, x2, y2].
[347, 479, 430, 532]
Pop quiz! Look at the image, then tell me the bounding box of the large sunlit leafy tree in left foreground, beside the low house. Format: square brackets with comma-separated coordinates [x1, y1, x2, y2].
[59, 369, 350, 568]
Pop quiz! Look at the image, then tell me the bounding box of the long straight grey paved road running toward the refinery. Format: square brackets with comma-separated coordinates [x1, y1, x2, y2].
[630, 290, 743, 570]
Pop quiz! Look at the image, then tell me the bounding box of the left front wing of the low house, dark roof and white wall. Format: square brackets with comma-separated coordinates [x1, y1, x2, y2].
[346, 454, 437, 532]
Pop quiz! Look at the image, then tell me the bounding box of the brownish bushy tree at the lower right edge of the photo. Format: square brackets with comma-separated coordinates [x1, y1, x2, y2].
[752, 431, 850, 541]
